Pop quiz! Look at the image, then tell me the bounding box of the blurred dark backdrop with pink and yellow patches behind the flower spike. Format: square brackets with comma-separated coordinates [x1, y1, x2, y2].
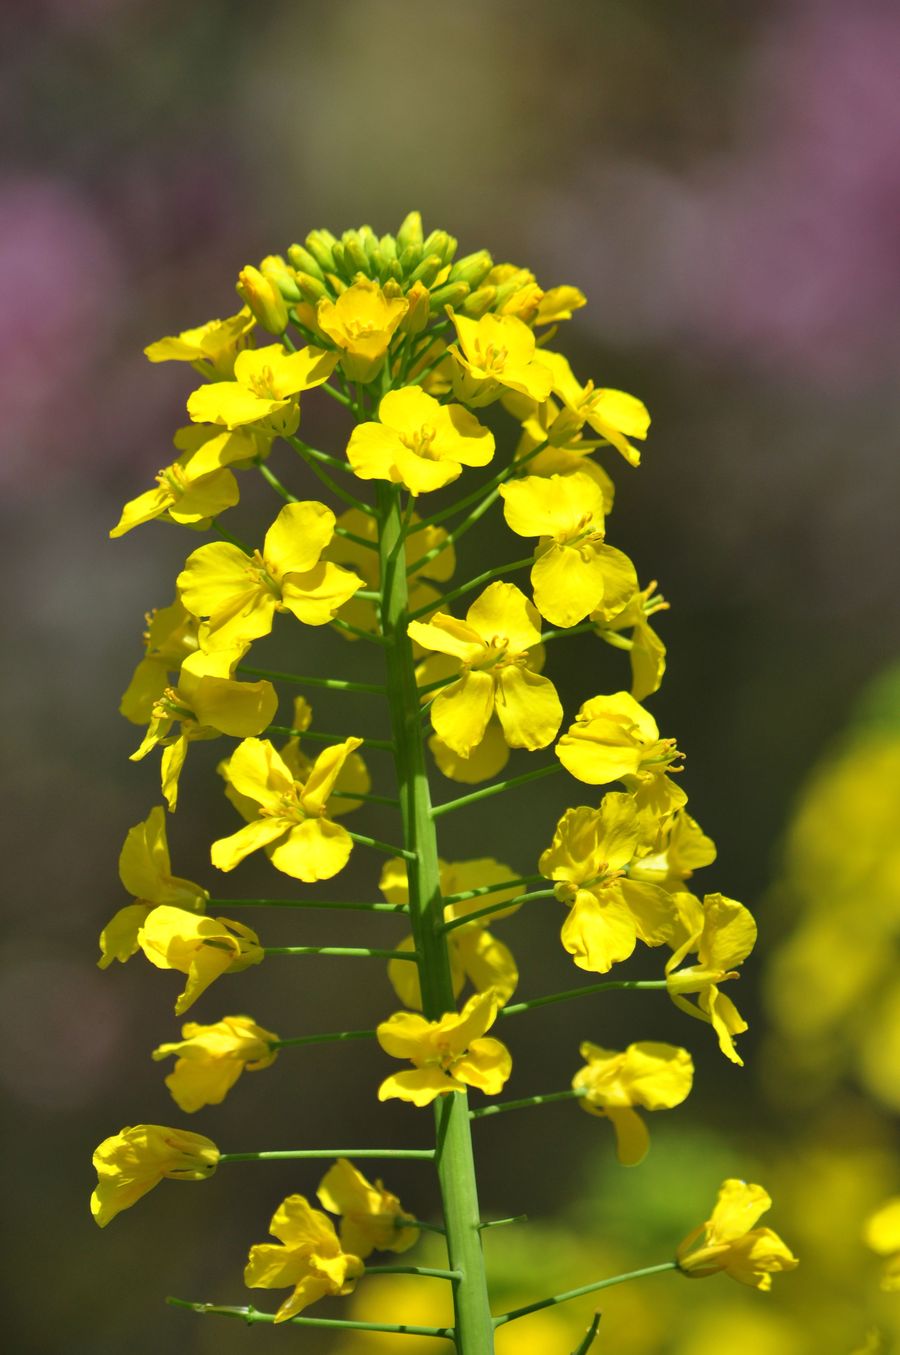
[0, 0, 900, 1355]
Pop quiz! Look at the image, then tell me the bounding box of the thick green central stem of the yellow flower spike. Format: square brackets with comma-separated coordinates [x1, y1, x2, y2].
[378, 485, 493, 1355]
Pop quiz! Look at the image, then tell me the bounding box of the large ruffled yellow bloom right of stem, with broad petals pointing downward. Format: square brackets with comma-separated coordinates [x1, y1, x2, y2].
[538, 793, 674, 974]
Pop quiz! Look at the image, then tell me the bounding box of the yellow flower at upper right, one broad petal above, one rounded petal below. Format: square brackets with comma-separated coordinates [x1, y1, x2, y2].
[500, 472, 637, 626]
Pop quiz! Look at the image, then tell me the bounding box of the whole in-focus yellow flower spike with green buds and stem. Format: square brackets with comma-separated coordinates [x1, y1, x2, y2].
[94, 213, 793, 1355]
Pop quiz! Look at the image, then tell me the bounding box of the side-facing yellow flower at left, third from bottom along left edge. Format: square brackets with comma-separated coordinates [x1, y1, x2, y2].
[137, 904, 264, 1016]
